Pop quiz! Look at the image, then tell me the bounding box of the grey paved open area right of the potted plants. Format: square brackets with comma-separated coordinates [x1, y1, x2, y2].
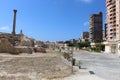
[74, 53, 120, 80]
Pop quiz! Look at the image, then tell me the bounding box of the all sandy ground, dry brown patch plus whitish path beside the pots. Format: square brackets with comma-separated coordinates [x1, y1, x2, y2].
[0, 51, 105, 80]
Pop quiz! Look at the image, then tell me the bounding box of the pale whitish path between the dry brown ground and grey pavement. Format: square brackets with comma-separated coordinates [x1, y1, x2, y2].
[52, 55, 105, 80]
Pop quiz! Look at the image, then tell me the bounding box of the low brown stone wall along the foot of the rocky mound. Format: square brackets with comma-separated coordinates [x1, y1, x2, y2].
[0, 38, 46, 54]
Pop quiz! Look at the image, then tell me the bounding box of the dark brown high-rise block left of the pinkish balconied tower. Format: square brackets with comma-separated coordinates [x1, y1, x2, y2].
[89, 12, 103, 42]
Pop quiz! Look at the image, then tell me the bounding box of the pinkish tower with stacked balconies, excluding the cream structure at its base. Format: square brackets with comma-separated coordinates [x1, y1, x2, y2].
[106, 0, 120, 41]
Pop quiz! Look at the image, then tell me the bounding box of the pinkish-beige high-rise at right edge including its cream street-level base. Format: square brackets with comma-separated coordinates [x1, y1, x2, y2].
[104, 0, 120, 53]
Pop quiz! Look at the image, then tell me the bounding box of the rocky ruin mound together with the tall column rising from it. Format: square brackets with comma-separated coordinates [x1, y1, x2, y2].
[0, 10, 46, 54]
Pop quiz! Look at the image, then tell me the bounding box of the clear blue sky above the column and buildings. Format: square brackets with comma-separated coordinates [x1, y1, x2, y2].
[0, 0, 105, 41]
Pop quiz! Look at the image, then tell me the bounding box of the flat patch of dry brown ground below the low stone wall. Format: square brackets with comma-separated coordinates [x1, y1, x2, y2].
[0, 53, 71, 80]
